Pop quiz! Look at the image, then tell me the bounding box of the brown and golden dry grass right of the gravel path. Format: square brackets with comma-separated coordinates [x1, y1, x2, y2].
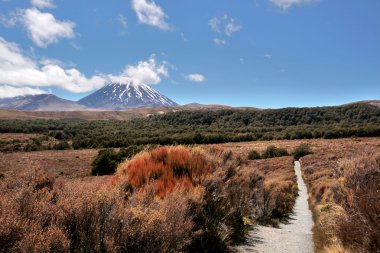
[301, 139, 380, 252]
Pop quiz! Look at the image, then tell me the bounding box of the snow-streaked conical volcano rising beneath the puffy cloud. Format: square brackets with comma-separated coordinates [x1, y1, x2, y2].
[78, 82, 177, 110]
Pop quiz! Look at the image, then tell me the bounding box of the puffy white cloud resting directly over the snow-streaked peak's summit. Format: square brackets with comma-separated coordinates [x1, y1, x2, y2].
[108, 56, 169, 84]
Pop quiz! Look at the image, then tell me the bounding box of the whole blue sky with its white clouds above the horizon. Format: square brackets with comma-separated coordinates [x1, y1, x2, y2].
[0, 0, 380, 108]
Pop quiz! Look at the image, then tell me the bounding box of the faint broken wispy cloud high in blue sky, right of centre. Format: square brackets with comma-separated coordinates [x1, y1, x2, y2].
[208, 14, 242, 46]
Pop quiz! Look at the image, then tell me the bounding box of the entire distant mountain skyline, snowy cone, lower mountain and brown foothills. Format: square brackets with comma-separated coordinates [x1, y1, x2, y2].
[0, 82, 380, 113]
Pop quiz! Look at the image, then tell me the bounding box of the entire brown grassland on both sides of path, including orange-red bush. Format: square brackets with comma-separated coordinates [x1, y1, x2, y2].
[0, 138, 380, 252]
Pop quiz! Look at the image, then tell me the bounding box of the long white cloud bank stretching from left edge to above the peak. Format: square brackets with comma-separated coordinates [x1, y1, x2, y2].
[0, 37, 174, 98]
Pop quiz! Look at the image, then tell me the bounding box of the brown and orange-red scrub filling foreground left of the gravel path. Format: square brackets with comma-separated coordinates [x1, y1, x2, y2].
[0, 143, 297, 252]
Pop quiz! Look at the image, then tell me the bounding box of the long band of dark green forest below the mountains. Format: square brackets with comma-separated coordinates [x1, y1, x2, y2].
[0, 104, 380, 149]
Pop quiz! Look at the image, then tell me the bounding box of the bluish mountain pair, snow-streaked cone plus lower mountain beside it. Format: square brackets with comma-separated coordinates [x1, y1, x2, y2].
[0, 82, 178, 111]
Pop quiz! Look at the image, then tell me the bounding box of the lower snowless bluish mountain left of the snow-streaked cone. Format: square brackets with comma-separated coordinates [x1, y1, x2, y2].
[0, 94, 87, 111]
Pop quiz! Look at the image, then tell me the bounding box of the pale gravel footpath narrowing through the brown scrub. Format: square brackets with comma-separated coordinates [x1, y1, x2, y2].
[237, 162, 314, 253]
